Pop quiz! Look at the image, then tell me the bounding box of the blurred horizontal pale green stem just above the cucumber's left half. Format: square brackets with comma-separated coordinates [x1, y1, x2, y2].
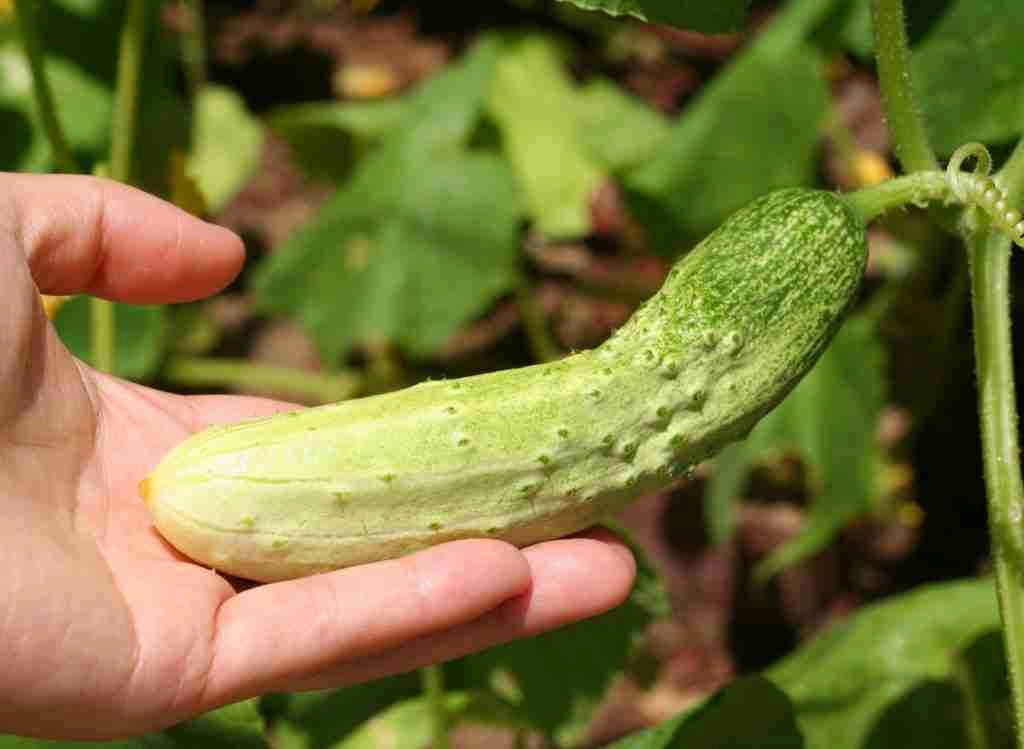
[162, 357, 362, 404]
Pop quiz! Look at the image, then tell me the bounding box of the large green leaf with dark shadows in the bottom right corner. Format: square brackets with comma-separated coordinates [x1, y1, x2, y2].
[612, 580, 1003, 749]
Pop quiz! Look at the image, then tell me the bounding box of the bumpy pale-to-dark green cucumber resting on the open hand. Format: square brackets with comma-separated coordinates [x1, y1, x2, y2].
[141, 189, 867, 581]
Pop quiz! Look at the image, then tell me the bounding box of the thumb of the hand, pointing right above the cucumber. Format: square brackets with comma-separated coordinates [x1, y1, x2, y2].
[0, 173, 245, 303]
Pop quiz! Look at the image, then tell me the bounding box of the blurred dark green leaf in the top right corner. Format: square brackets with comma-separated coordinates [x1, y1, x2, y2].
[910, 0, 1024, 156]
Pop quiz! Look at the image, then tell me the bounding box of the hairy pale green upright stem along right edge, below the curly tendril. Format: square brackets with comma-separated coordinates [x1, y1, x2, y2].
[967, 231, 1024, 747]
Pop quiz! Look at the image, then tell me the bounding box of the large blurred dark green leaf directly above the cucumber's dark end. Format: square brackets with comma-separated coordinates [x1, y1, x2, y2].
[625, 0, 834, 254]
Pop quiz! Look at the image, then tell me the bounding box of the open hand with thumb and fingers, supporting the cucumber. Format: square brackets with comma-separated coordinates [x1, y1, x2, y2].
[0, 173, 635, 740]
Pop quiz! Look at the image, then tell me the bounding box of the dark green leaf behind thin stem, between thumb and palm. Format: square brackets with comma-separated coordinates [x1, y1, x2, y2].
[53, 295, 168, 381]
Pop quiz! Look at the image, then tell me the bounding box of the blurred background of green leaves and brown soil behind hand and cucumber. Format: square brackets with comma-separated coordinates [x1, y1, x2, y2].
[6, 0, 1024, 749]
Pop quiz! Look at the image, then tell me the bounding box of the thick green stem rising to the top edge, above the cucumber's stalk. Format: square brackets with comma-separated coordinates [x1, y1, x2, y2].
[871, 0, 938, 172]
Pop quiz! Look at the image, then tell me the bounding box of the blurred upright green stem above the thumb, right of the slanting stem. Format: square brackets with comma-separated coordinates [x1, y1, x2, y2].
[111, 0, 147, 184]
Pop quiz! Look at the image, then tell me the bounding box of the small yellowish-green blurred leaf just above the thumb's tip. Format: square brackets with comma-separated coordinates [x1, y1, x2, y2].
[187, 85, 263, 212]
